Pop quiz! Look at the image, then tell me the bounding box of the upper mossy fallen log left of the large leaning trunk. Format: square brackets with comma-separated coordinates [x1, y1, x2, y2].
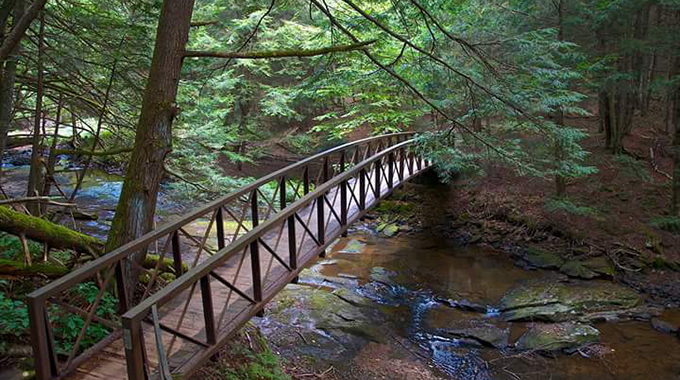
[0, 206, 104, 256]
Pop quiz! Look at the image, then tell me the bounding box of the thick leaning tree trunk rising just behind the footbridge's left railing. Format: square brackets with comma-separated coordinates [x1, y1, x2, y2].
[106, 0, 194, 288]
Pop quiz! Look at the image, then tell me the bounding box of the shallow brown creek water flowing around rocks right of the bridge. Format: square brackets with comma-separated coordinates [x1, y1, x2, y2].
[262, 231, 680, 380]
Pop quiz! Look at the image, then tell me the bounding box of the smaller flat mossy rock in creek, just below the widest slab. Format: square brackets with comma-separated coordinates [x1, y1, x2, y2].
[515, 322, 600, 351]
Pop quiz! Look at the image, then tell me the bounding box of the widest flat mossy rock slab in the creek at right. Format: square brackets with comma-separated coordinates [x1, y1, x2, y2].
[499, 278, 642, 322]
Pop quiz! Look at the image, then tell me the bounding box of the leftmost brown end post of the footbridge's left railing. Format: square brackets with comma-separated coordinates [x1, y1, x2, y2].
[28, 296, 58, 380]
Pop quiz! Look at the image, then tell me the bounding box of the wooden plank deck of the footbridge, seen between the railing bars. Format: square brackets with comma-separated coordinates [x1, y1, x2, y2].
[64, 159, 417, 380]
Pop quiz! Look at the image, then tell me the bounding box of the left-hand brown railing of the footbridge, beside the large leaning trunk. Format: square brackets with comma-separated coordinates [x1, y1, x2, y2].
[27, 133, 412, 380]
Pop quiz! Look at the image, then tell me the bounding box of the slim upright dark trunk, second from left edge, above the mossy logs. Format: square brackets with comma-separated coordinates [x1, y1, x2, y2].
[26, 14, 45, 215]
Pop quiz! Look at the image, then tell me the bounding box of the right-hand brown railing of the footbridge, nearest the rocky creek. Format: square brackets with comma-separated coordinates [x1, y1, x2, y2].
[122, 140, 428, 380]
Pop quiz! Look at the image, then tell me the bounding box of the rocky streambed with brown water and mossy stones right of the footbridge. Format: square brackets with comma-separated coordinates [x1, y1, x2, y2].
[258, 230, 680, 380]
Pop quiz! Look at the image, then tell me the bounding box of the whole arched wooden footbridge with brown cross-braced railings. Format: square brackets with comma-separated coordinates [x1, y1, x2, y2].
[28, 133, 429, 380]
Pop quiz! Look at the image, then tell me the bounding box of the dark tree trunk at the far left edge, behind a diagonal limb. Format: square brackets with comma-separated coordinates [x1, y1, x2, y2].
[0, 0, 24, 163]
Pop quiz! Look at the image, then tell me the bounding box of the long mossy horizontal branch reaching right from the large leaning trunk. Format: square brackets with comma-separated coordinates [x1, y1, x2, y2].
[184, 40, 376, 59]
